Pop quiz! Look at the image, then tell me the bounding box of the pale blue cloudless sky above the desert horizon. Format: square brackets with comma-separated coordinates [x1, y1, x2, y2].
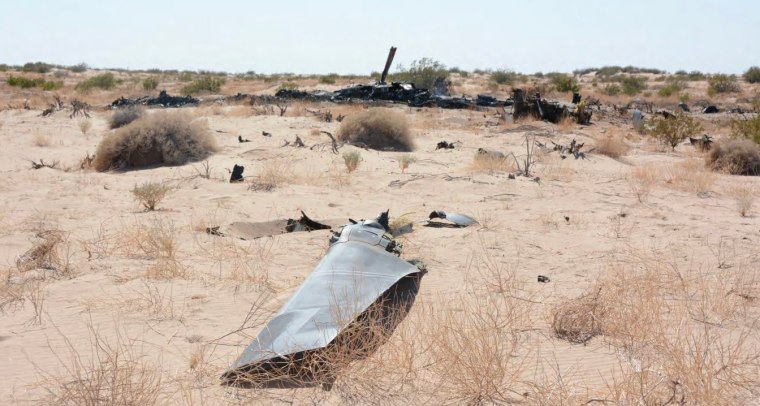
[0, 0, 760, 74]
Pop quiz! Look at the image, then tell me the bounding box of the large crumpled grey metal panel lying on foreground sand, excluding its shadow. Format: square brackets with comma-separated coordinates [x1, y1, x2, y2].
[222, 214, 423, 387]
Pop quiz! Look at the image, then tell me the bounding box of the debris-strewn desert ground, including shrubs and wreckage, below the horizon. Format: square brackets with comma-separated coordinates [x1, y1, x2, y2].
[0, 68, 760, 405]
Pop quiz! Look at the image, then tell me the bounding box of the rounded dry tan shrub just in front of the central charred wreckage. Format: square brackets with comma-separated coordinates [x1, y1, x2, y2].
[338, 108, 414, 152]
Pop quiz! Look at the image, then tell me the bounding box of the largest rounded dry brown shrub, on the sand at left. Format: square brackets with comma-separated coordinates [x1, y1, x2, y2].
[94, 111, 219, 171]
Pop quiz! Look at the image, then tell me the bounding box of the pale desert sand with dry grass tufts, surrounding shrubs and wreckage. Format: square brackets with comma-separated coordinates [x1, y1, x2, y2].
[0, 71, 760, 404]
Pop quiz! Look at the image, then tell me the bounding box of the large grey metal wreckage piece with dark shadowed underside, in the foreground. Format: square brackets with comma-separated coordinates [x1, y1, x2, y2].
[221, 211, 426, 390]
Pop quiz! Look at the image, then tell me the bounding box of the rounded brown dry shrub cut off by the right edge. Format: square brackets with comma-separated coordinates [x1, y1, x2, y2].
[705, 139, 760, 176]
